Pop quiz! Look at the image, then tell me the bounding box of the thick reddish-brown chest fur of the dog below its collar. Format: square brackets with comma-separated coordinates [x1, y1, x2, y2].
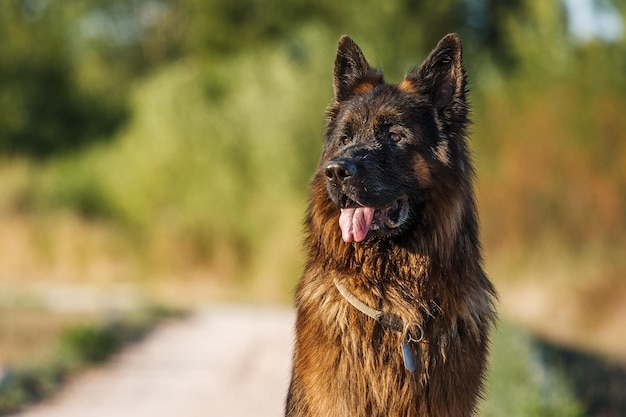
[287, 271, 493, 417]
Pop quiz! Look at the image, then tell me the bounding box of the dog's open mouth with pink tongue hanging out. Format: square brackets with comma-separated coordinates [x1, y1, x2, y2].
[339, 196, 409, 242]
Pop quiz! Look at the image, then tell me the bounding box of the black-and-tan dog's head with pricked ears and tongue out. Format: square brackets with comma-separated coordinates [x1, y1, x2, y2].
[320, 34, 469, 242]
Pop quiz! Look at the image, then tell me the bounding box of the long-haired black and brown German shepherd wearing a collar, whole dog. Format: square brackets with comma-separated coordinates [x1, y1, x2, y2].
[286, 34, 496, 417]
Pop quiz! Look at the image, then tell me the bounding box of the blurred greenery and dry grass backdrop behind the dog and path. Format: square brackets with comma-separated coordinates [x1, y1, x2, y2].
[0, 0, 626, 416]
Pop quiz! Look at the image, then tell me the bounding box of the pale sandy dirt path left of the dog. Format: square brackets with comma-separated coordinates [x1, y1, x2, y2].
[18, 306, 294, 417]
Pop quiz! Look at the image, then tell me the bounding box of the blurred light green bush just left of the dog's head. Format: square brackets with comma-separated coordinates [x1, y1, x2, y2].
[20, 28, 336, 286]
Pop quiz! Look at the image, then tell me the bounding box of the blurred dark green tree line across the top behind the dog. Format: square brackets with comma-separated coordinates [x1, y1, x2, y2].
[0, 0, 624, 157]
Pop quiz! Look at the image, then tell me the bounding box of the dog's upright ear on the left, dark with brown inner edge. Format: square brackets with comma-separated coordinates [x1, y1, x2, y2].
[333, 35, 383, 102]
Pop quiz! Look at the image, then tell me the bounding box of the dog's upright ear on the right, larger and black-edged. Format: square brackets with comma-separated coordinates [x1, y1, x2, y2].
[400, 33, 467, 110]
